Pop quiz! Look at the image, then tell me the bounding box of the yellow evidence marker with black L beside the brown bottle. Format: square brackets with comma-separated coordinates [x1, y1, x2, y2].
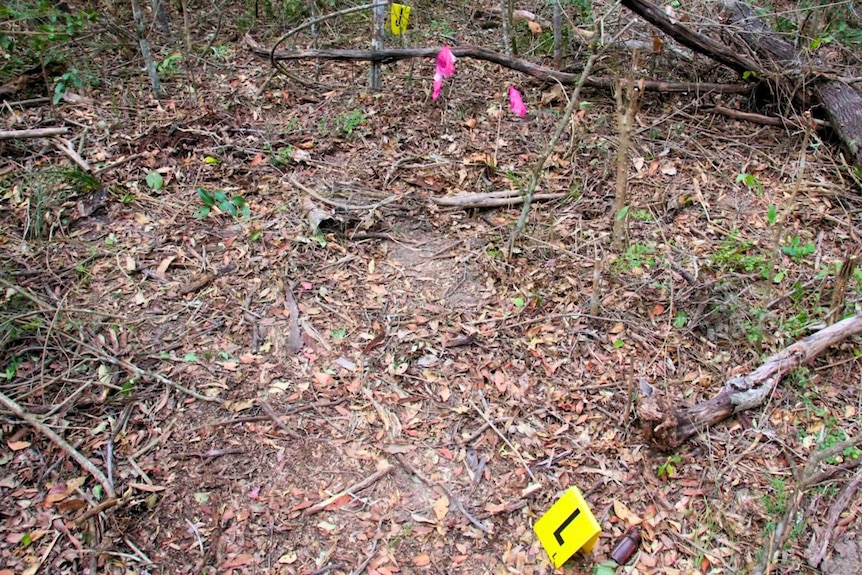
[533, 486, 602, 568]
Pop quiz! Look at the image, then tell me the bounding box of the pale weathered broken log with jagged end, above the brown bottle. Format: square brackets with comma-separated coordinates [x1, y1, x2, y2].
[638, 314, 862, 450]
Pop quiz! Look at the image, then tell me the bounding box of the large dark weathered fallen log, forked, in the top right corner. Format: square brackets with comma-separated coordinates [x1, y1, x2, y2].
[621, 0, 862, 168]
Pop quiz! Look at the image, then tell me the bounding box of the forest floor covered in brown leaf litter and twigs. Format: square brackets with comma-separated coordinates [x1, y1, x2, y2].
[0, 2, 862, 575]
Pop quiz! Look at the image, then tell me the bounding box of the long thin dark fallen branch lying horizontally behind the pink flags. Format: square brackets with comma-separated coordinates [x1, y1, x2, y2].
[245, 35, 751, 94]
